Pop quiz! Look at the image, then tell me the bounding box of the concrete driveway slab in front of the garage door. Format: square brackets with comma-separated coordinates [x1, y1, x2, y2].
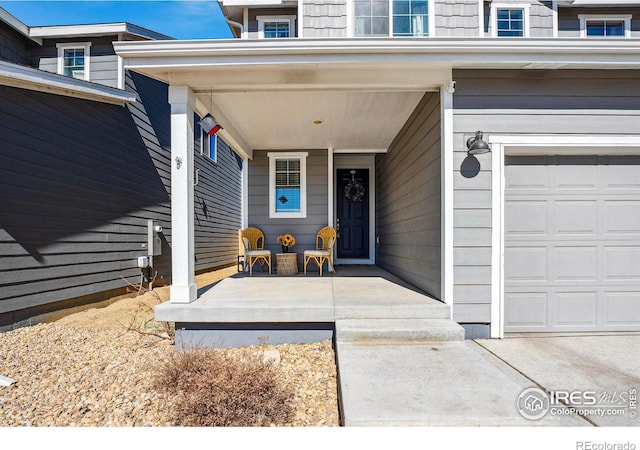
[475, 334, 640, 426]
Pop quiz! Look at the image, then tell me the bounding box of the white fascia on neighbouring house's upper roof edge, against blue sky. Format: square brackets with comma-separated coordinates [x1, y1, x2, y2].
[29, 22, 173, 40]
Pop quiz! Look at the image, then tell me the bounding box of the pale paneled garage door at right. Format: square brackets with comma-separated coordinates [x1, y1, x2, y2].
[504, 156, 640, 332]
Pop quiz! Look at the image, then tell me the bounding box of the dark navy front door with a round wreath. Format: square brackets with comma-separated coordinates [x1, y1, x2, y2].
[336, 169, 369, 259]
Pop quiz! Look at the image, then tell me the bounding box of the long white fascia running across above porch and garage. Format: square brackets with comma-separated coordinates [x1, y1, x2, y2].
[114, 38, 640, 70]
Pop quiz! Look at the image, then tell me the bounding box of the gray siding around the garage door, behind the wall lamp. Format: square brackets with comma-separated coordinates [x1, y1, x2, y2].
[453, 70, 640, 323]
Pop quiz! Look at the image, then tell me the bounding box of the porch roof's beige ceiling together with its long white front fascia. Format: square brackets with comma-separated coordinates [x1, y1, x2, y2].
[114, 38, 640, 157]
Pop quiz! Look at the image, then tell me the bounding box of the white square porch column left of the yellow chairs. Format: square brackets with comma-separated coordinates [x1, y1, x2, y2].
[169, 86, 198, 303]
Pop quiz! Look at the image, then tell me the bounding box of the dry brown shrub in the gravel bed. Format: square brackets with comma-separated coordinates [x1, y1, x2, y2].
[156, 348, 293, 427]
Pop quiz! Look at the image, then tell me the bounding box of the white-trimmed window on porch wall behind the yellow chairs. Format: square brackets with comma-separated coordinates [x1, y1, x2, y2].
[267, 152, 308, 218]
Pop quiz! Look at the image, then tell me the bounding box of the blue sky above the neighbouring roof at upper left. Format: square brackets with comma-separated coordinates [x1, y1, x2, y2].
[0, 0, 232, 39]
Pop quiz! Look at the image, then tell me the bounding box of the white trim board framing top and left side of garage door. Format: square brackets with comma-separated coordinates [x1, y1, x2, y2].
[487, 134, 640, 338]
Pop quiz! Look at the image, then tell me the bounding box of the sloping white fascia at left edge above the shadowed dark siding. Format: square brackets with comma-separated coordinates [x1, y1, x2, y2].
[0, 61, 136, 105]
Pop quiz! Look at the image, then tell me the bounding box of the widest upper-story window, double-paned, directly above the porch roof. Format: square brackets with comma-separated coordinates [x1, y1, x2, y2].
[354, 0, 429, 36]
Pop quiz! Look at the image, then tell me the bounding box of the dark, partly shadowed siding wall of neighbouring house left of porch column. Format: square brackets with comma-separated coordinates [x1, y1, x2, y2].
[0, 78, 170, 325]
